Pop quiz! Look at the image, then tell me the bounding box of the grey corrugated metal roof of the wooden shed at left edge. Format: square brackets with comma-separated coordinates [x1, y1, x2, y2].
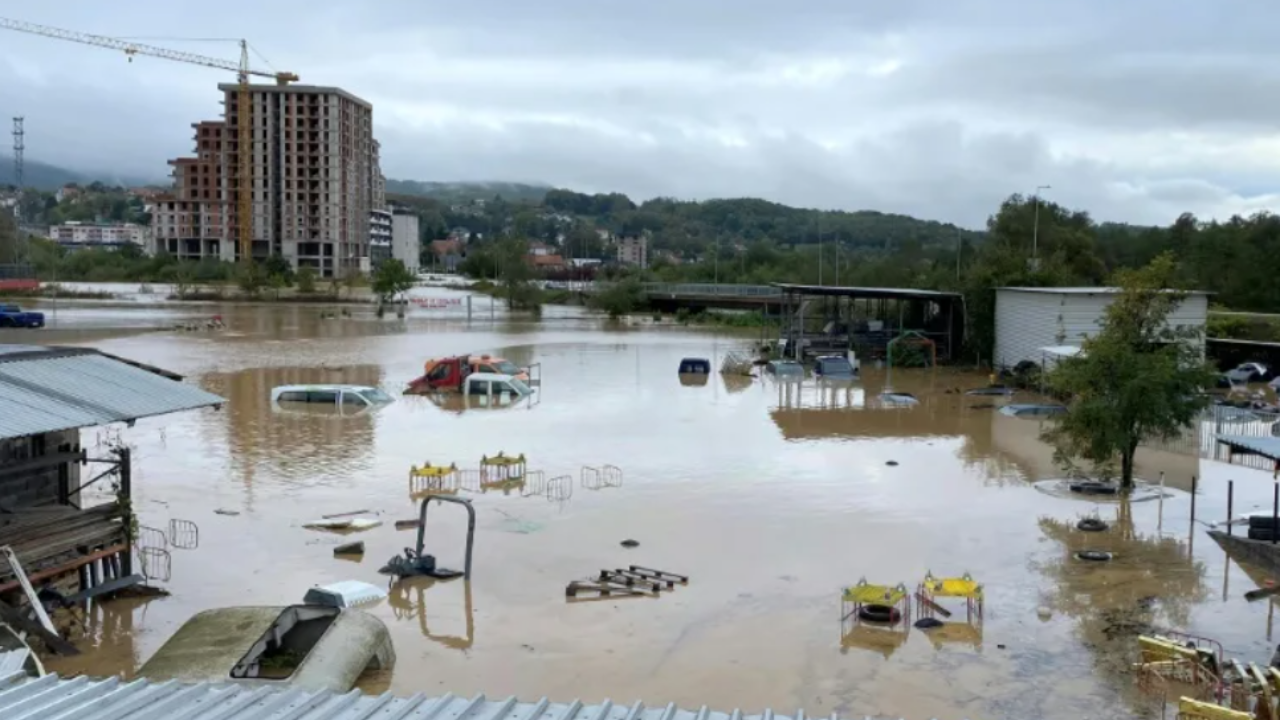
[0, 346, 225, 438]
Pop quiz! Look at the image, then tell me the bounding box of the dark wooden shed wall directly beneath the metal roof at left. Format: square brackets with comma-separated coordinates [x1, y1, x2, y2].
[0, 430, 81, 510]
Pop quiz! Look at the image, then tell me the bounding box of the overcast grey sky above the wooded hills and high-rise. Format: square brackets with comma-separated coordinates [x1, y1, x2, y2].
[0, 0, 1280, 227]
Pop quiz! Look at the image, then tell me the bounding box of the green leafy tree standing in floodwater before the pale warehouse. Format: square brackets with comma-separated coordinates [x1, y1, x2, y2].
[1044, 254, 1213, 489]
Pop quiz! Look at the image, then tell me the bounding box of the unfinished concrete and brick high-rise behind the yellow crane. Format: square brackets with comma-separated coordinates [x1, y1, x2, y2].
[152, 83, 385, 277]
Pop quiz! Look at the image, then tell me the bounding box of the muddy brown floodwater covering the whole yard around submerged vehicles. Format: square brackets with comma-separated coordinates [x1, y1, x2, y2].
[15, 284, 1274, 719]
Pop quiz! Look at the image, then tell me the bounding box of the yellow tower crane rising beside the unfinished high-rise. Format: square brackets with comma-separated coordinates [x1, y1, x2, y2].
[0, 18, 298, 263]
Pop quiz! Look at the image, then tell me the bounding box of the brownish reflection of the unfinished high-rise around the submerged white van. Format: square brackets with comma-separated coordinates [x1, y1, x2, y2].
[200, 365, 383, 483]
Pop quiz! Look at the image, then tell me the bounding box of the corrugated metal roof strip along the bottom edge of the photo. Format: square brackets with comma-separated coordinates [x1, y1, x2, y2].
[0, 674, 952, 720]
